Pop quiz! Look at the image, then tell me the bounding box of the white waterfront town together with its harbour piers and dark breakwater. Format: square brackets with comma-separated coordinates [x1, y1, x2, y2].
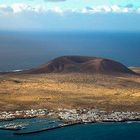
[0, 108, 140, 135]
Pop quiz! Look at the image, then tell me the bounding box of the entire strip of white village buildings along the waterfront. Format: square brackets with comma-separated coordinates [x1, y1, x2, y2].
[0, 109, 140, 123]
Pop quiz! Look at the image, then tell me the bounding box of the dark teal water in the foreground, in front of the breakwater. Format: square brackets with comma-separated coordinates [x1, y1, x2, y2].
[0, 119, 140, 140]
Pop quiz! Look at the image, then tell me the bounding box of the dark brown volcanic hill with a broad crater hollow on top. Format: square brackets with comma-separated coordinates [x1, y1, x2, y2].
[25, 56, 136, 74]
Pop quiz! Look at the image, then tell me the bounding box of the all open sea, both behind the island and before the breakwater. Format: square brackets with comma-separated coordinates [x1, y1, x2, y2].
[0, 31, 140, 140]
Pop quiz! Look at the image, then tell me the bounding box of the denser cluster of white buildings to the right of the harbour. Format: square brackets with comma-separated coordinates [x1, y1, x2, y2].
[58, 109, 140, 122]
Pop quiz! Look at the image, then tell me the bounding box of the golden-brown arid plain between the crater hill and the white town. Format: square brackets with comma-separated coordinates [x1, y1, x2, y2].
[0, 68, 140, 111]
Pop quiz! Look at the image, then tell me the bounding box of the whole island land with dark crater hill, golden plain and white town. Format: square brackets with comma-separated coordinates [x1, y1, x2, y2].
[0, 56, 140, 124]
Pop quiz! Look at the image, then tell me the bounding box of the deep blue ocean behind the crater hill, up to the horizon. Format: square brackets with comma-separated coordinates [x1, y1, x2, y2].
[0, 31, 140, 71]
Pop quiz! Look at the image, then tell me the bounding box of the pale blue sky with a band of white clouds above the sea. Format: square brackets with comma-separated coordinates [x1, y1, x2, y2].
[0, 0, 140, 32]
